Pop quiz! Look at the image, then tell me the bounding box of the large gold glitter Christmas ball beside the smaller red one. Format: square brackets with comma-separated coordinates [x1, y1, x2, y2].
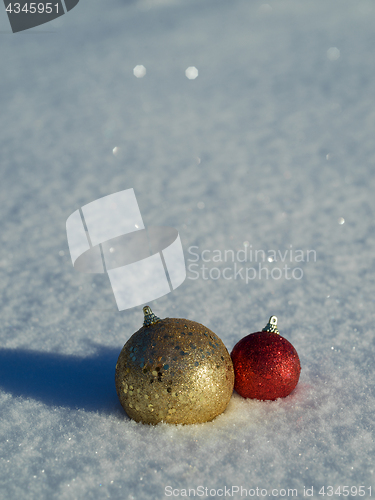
[116, 306, 234, 424]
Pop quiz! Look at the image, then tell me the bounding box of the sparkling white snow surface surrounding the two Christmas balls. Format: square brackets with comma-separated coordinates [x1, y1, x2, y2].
[0, 0, 375, 500]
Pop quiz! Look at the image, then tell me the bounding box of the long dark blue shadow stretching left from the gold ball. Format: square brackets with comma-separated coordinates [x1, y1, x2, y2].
[0, 346, 129, 415]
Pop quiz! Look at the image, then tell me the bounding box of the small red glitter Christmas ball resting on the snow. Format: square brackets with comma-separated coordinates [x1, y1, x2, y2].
[231, 316, 301, 400]
